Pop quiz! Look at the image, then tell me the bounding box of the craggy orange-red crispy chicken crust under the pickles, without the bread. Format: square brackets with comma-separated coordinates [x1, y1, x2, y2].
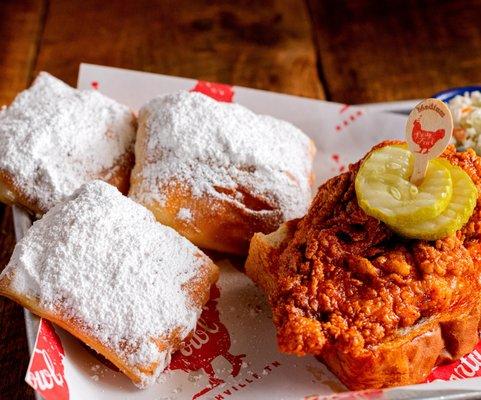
[268, 142, 481, 357]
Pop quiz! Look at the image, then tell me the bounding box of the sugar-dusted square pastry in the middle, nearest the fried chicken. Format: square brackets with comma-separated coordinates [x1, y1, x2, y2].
[129, 92, 315, 254]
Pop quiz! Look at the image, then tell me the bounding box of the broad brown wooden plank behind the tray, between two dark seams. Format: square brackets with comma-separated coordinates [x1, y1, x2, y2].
[36, 0, 323, 98]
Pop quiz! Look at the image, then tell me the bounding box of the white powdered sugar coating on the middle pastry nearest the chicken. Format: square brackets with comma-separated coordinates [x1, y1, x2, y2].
[130, 91, 313, 222]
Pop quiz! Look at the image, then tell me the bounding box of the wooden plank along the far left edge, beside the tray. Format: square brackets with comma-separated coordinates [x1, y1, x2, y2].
[0, 0, 45, 399]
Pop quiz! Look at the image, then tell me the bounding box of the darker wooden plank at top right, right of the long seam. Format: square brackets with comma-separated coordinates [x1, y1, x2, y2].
[308, 0, 481, 104]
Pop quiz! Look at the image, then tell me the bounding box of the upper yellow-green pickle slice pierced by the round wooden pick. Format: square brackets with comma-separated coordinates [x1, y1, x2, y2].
[355, 146, 453, 226]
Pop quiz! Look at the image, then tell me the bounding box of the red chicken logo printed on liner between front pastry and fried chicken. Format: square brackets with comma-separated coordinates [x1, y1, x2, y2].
[169, 285, 246, 399]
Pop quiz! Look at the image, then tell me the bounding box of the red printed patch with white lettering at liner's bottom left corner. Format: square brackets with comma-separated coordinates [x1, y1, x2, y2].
[25, 318, 69, 400]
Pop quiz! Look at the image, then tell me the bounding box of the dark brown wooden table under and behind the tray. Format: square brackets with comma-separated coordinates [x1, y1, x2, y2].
[0, 0, 481, 399]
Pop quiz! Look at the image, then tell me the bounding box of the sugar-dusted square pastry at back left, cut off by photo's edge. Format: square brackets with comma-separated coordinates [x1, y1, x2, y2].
[0, 72, 136, 215]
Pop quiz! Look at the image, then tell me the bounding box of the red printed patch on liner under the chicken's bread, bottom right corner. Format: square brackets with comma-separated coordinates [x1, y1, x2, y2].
[426, 342, 481, 382]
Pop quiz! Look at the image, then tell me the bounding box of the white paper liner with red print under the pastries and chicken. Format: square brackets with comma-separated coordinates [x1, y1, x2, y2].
[10, 64, 481, 400]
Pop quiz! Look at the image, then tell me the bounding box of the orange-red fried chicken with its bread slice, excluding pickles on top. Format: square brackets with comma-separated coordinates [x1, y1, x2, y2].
[246, 142, 481, 389]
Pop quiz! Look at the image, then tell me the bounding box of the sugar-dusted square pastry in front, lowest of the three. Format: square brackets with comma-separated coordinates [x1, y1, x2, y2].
[0, 181, 218, 387]
